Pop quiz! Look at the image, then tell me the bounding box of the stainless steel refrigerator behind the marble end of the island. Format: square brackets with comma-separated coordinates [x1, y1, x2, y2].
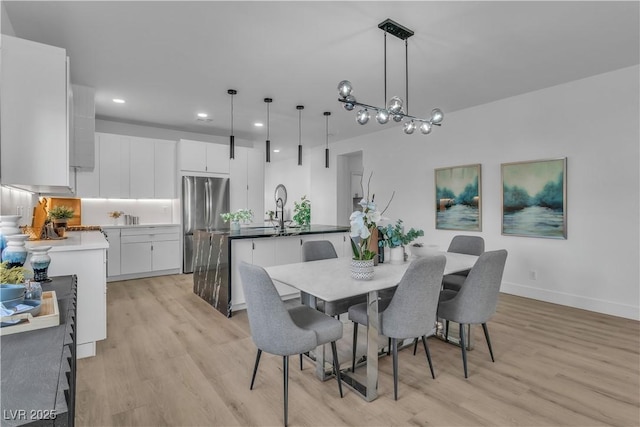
[182, 176, 229, 273]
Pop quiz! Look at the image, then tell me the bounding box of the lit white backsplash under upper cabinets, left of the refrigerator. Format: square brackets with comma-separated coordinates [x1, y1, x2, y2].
[82, 199, 180, 225]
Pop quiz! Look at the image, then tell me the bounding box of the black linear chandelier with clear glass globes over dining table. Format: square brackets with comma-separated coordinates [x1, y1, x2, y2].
[338, 19, 444, 135]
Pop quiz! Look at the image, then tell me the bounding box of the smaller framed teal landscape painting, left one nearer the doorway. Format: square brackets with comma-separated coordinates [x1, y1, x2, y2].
[435, 164, 482, 231]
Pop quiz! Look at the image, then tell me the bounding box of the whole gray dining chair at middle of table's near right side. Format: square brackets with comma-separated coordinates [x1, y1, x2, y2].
[349, 255, 446, 400]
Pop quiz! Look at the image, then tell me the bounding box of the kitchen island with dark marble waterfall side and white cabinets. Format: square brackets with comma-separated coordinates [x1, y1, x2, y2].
[193, 225, 351, 317]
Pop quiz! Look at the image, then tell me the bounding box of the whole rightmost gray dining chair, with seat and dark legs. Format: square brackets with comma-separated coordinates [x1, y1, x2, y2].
[438, 249, 507, 378]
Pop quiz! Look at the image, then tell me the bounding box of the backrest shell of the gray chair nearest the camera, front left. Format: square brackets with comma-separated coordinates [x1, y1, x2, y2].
[240, 262, 317, 356]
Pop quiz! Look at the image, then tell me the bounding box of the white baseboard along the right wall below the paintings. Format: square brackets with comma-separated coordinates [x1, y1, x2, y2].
[500, 282, 640, 320]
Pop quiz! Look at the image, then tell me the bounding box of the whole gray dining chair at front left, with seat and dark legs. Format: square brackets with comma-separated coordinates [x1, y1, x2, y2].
[240, 262, 343, 426]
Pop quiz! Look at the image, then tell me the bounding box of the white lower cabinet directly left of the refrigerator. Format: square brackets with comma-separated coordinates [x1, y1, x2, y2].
[109, 225, 181, 281]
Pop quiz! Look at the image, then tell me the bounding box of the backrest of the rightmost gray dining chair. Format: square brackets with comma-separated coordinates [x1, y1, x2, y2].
[446, 249, 507, 324]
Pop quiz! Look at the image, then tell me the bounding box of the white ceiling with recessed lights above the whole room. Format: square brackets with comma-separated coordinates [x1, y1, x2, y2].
[2, 1, 640, 152]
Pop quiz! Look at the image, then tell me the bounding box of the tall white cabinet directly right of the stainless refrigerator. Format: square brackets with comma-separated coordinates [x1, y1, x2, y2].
[229, 147, 264, 222]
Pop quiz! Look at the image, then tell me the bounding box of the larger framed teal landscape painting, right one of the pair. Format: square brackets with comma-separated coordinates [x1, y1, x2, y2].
[502, 157, 567, 239]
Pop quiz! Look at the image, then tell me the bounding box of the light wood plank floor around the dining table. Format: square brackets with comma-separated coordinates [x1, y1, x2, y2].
[76, 275, 640, 426]
